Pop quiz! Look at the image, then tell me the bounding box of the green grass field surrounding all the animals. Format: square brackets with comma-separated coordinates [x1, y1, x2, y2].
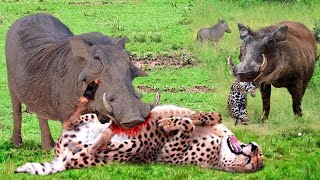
[0, 0, 320, 179]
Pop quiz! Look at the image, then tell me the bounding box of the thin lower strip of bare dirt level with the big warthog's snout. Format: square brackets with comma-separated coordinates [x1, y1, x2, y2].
[137, 85, 215, 93]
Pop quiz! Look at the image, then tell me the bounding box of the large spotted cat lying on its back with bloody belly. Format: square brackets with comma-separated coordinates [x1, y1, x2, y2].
[15, 81, 263, 175]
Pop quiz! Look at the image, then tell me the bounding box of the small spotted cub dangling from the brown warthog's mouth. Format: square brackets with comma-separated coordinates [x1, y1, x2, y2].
[228, 79, 258, 125]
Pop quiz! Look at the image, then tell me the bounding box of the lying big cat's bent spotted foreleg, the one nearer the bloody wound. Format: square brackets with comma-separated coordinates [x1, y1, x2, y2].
[157, 117, 195, 164]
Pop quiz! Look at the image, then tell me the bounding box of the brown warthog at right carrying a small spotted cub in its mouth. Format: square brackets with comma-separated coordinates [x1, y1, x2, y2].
[228, 21, 317, 120]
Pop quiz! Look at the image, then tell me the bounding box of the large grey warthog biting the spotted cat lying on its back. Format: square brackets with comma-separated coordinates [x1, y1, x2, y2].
[6, 14, 158, 149]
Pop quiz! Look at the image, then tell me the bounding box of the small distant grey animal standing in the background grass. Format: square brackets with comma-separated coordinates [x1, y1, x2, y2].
[197, 20, 231, 43]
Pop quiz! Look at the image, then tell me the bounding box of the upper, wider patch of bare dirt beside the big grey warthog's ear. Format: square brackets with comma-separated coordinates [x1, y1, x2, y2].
[131, 53, 197, 70]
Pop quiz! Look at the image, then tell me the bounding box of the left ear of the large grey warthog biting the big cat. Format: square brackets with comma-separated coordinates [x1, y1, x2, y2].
[69, 37, 90, 58]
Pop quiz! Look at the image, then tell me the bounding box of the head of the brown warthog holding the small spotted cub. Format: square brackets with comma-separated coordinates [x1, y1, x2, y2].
[228, 24, 288, 82]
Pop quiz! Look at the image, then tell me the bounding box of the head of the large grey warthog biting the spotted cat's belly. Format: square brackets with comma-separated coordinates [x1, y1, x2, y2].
[69, 33, 159, 128]
